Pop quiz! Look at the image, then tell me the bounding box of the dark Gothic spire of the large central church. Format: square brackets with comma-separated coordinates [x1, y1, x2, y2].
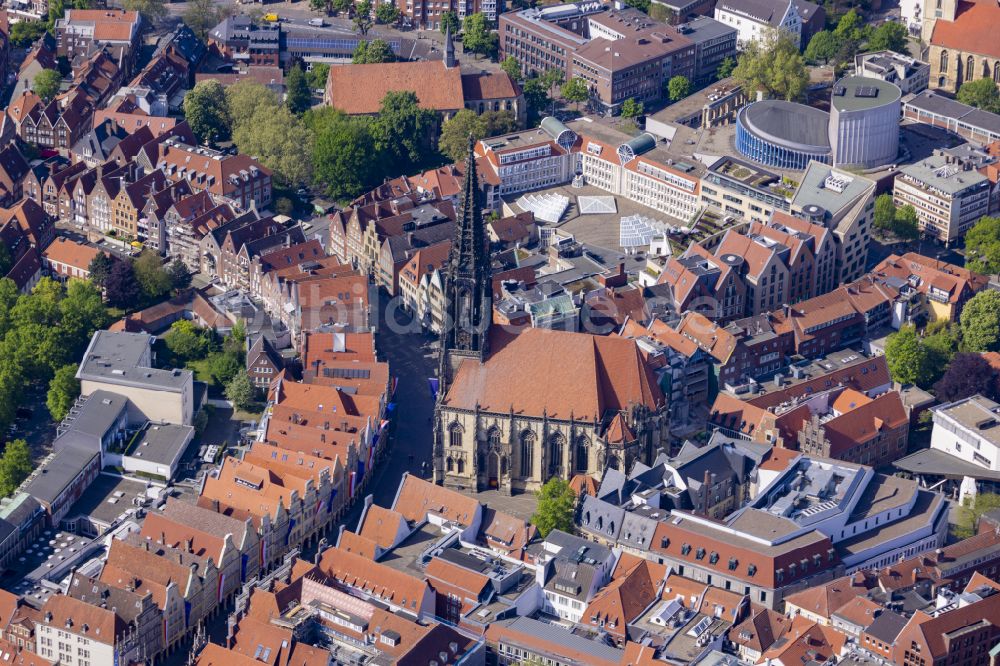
[440, 135, 493, 384]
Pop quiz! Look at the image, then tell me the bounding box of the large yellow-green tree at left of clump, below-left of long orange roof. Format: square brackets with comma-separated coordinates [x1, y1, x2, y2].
[233, 107, 314, 186]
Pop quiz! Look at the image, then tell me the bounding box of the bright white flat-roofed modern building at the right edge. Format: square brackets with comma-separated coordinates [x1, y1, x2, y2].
[931, 395, 1000, 472]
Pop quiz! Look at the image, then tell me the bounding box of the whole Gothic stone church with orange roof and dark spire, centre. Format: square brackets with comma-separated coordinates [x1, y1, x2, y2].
[434, 140, 667, 493]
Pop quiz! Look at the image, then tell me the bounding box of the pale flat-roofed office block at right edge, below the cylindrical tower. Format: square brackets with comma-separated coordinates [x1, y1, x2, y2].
[892, 153, 990, 243]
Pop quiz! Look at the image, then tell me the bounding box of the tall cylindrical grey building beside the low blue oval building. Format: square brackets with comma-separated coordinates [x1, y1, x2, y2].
[829, 76, 902, 169]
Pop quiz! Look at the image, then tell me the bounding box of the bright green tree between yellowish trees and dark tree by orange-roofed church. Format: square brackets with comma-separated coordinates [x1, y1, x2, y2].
[307, 107, 379, 201]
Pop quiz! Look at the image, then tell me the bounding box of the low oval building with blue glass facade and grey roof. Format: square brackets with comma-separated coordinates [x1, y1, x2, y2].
[736, 99, 830, 170]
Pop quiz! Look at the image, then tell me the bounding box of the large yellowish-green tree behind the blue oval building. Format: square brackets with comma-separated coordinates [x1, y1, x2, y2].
[733, 32, 809, 101]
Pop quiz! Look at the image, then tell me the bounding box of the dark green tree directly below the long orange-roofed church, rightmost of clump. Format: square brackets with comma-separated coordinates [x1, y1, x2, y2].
[371, 90, 437, 171]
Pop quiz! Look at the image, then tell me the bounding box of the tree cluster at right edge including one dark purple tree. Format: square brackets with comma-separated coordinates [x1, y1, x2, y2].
[885, 290, 1000, 392]
